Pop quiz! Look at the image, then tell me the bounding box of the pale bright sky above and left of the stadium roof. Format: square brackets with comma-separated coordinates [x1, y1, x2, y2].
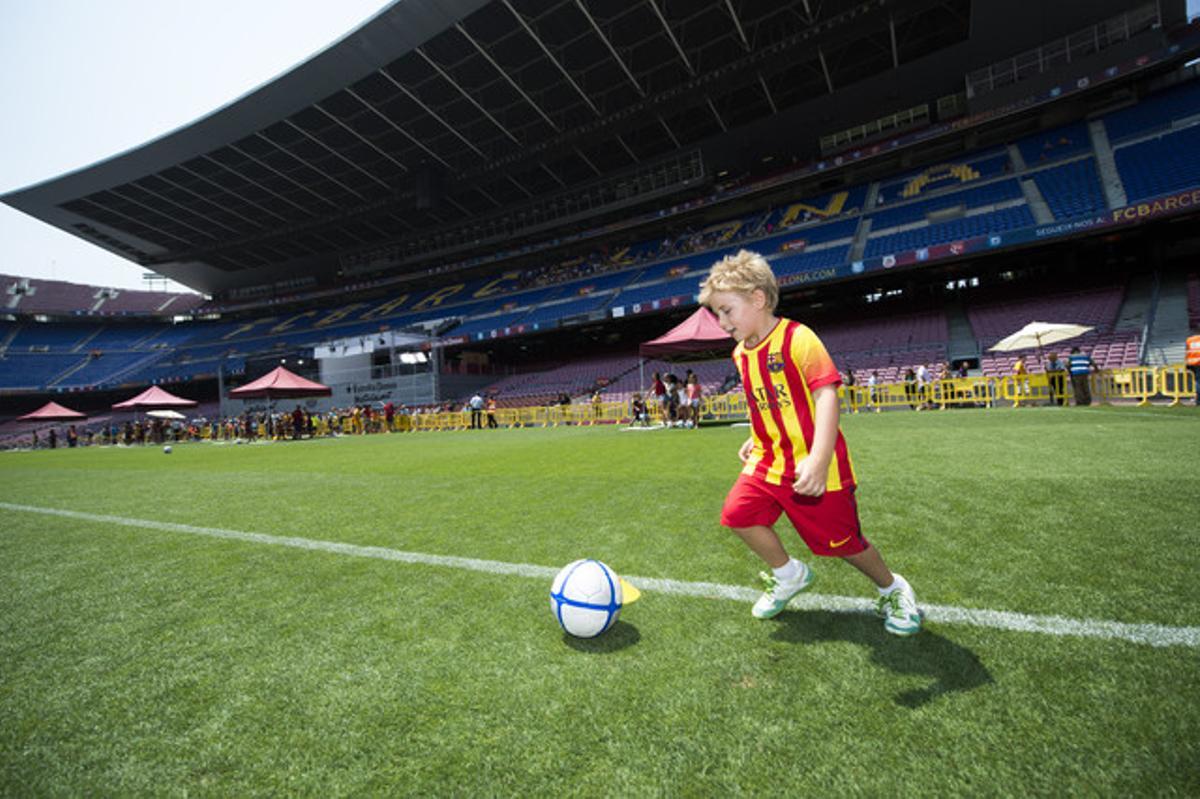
[0, 0, 396, 290]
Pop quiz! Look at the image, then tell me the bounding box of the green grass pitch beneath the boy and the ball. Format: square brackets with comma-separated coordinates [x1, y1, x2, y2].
[0, 408, 1200, 797]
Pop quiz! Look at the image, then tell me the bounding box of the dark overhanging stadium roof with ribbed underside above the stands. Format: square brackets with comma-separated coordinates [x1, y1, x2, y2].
[2, 0, 1152, 293]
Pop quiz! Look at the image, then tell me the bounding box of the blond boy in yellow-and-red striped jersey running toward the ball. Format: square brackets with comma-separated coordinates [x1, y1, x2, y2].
[700, 250, 922, 636]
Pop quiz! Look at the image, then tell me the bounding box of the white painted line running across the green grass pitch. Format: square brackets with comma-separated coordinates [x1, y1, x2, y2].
[0, 501, 1200, 648]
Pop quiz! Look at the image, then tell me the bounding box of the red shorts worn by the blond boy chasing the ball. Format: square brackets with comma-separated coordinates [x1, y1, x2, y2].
[721, 474, 869, 558]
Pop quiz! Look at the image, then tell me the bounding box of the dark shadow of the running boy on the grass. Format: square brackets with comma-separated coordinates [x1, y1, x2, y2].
[770, 611, 994, 708]
